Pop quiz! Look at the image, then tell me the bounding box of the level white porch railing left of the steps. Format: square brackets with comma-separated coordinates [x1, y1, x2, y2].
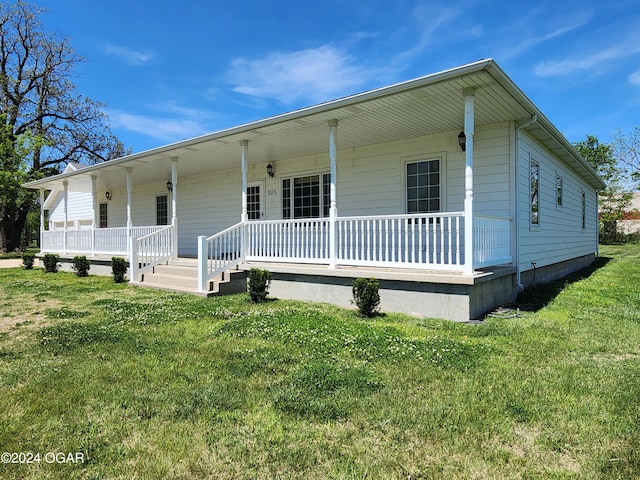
[41, 226, 166, 255]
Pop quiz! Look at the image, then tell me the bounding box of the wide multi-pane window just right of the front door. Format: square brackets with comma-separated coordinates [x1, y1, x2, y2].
[282, 173, 331, 219]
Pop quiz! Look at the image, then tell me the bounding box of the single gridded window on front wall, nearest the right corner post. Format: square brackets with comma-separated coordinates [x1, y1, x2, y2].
[407, 160, 440, 213]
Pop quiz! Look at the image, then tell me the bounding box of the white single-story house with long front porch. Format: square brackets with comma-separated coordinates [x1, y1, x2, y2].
[26, 60, 604, 321]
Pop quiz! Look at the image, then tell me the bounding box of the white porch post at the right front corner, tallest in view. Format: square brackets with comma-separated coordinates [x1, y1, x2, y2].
[463, 88, 475, 275]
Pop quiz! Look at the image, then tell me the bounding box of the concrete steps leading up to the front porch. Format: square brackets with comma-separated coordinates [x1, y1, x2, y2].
[140, 259, 247, 297]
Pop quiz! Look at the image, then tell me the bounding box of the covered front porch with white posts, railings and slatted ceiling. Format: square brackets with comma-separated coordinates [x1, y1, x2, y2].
[28, 58, 527, 293]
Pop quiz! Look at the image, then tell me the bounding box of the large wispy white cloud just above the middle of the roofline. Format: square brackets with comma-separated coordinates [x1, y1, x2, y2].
[230, 45, 375, 104]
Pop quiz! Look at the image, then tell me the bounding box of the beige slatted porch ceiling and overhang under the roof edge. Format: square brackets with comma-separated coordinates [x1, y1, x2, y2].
[26, 60, 604, 192]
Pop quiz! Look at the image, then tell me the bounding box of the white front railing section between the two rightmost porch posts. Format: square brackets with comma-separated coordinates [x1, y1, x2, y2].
[336, 212, 464, 270]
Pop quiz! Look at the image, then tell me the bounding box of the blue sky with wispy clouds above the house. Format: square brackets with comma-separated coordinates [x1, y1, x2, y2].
[40, 0, 640, 152]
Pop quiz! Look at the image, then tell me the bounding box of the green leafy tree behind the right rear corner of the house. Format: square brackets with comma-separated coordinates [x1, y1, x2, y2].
[574, 135, 632, 243]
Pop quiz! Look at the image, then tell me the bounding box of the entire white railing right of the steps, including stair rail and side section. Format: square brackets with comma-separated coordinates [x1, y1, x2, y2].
[198, 212, 512, 291]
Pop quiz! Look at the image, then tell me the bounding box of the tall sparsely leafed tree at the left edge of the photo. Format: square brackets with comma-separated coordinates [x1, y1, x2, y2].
[0, 0, 125, 251]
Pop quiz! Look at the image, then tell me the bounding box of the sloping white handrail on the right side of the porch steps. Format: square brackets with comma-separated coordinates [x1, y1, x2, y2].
[198, 223, 247, 292]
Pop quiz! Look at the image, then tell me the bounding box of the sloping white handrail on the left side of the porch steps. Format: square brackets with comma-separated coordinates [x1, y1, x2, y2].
[129, 225, 176, 283]
